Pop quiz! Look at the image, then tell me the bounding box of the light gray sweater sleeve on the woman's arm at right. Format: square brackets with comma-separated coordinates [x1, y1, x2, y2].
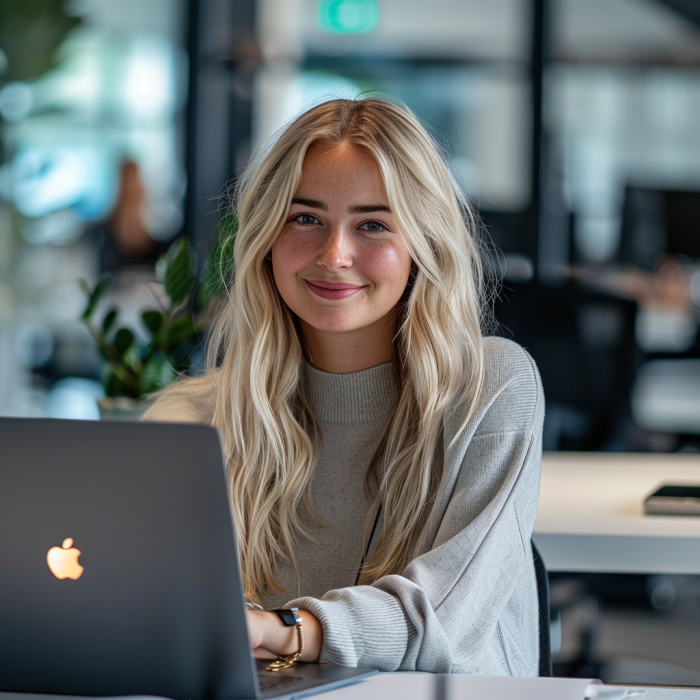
[293, 343, 544, 675]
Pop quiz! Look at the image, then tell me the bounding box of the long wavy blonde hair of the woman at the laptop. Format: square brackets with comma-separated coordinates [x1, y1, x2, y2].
[208, 98, 484, 602]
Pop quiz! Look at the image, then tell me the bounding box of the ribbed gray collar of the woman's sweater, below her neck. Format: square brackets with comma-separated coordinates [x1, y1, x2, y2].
[304, 362, 398, 423]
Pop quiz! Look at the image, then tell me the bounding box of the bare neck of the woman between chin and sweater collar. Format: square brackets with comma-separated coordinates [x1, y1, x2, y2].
[300, 314, 396, 374]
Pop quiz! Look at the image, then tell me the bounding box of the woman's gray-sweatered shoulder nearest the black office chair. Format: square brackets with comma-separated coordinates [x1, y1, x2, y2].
[454, 337, 544, 435]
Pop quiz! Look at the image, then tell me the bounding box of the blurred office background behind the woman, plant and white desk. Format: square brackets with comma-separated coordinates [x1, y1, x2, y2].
[0, 0, 700, 680]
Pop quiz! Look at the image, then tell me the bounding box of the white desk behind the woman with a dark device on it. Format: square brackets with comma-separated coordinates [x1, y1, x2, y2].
[533, 452, 700, 574]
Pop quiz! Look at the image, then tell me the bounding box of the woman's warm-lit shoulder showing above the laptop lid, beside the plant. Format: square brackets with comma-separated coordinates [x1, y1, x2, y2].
[142, 372, 219, 425]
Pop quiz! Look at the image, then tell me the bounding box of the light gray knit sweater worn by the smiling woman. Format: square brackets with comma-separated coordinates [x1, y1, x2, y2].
[145, 338, 544, 675]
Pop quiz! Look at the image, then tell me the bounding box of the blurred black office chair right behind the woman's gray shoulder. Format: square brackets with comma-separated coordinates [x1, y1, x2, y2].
[494, 282, 638, 451]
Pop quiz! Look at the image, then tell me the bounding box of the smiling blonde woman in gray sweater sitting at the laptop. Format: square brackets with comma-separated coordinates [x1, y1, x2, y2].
[146, 99, 544, 675]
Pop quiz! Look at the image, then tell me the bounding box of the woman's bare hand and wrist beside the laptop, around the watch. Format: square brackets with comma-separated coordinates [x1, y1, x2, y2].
[246, 610, 323, 662]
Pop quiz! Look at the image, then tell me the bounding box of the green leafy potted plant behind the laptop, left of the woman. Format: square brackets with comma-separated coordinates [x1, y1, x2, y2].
[79, 224, 236, 420]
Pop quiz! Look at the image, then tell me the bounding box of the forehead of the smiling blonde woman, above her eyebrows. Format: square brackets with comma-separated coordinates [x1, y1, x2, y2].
[297, 141, 387, 201]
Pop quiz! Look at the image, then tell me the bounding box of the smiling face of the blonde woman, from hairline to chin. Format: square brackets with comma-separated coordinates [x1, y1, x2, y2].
[272, 143, 411, 348]
